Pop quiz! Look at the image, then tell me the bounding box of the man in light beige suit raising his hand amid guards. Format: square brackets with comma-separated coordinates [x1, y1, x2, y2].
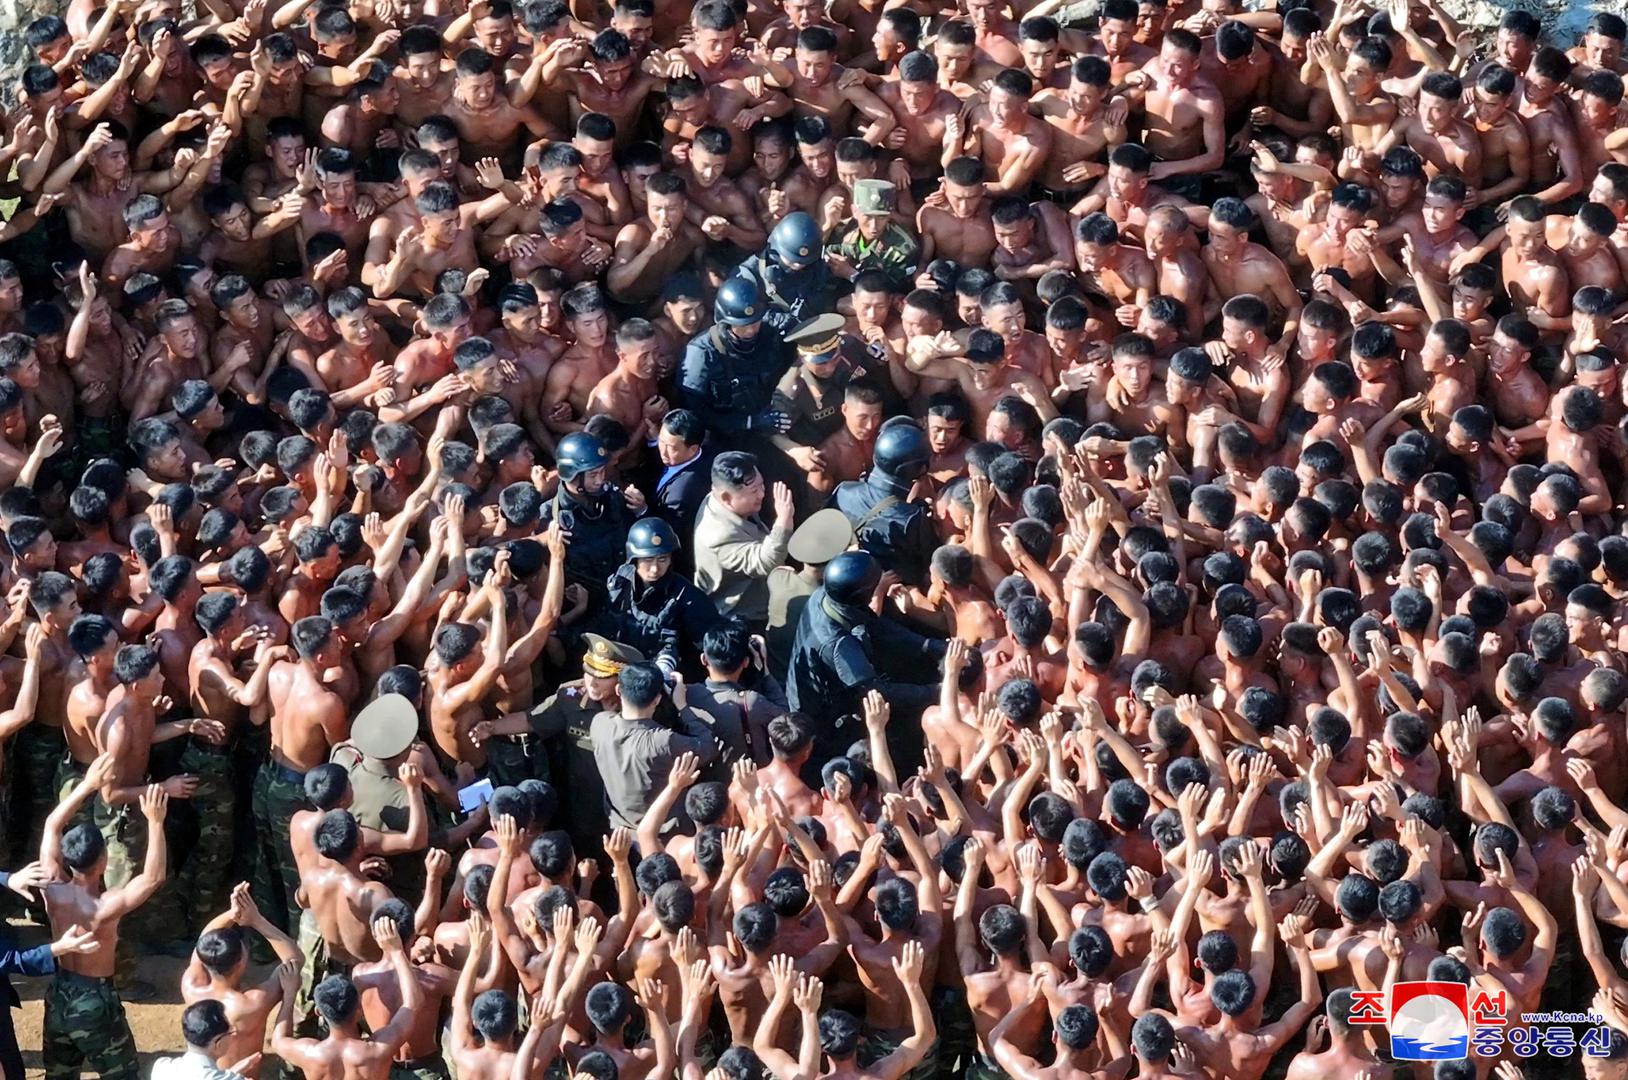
[694, 453, 794, 627]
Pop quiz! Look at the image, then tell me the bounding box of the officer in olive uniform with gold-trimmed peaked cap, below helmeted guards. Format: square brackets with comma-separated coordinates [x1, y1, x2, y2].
[531, 634, 645, 857]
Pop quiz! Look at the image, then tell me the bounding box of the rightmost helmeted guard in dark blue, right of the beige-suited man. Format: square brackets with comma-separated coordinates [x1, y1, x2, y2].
[832, 417, 938, 588]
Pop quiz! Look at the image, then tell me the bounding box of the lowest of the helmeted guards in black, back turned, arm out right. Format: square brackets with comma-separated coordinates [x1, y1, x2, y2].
[786, 551, 944, 761]
